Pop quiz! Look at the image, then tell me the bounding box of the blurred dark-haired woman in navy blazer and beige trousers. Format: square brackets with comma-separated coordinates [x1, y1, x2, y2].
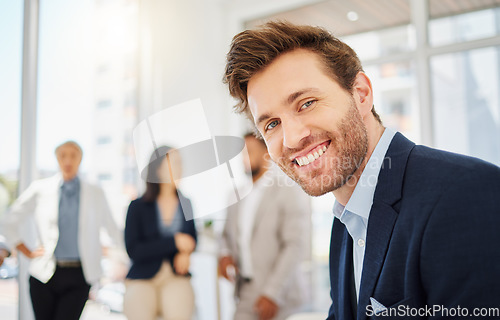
[124, 146, 197, 320]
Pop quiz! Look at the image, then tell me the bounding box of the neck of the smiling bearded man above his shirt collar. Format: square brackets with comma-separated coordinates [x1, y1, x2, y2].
[333, 125, 385, 207]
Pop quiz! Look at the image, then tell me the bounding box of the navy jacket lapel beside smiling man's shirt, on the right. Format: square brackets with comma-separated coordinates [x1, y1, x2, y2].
[357, 133, 415, 320]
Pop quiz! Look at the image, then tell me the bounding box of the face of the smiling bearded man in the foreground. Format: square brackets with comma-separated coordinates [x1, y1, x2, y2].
[248, 49, 368, 196]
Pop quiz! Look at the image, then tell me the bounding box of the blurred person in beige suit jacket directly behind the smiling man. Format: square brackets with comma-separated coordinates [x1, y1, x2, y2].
[219, 133, 311, 320]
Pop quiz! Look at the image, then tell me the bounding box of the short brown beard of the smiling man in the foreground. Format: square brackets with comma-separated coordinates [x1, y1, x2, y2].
[278, 101, 368, 197]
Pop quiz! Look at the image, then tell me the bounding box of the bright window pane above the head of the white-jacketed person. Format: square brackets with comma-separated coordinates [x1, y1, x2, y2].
[37, 0, 94, 177]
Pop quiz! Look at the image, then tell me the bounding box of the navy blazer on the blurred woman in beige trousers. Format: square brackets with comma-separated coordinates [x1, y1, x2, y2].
[125, 192, 197, 279]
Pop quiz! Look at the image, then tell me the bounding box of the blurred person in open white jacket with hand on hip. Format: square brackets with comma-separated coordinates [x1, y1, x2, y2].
[0, 141, 123, 320]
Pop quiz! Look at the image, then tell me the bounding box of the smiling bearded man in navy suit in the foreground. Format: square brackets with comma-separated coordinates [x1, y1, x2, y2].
[224, 22, 500, 320]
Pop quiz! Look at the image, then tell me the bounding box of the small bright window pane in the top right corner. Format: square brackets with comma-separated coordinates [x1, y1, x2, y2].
[429, 8, 500, 46]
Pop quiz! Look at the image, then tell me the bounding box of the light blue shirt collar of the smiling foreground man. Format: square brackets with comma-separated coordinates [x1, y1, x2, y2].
[333, 128, 396, 220]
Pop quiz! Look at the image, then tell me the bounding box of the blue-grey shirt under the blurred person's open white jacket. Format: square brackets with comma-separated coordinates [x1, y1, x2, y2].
[54, 177, 80, 261]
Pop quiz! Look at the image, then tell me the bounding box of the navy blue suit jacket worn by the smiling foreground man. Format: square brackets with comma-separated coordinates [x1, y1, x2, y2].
[328, 133, 500, 320]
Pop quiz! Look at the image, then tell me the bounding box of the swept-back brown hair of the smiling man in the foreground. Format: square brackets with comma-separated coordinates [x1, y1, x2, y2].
[223, 21, 381, 122]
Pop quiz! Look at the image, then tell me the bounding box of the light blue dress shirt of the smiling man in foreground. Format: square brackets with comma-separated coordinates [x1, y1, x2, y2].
[333, 128, 396, 299]
